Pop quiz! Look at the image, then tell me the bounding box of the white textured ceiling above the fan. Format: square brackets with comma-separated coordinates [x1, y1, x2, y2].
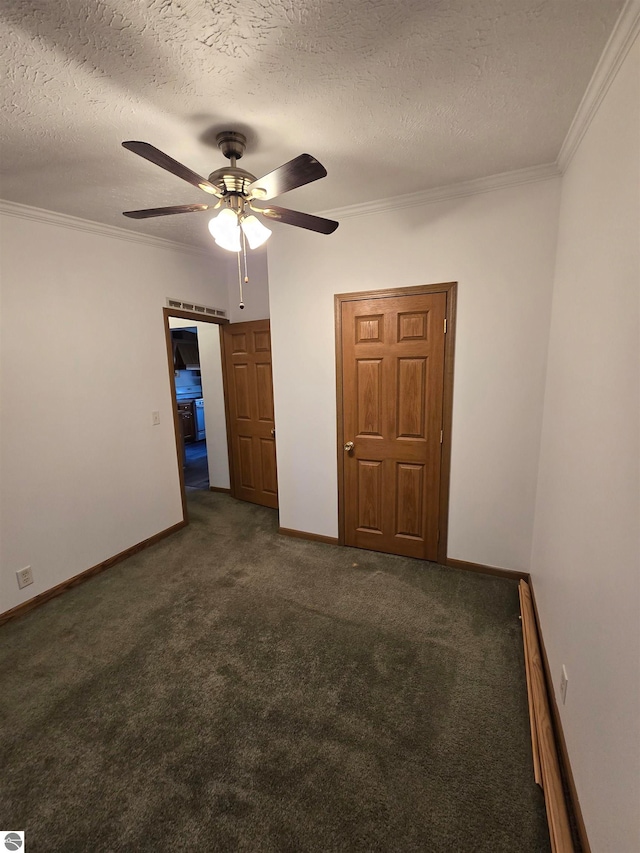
[0, 0, 622, 245]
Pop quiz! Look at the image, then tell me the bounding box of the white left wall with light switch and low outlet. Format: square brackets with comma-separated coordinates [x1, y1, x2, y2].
[0, 211, 227, 612]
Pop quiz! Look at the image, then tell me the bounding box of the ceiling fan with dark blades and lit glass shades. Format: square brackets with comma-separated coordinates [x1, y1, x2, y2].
[122, 130, 339, 252]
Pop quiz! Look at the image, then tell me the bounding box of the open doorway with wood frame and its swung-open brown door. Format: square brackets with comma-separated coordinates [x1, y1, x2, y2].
[163, 308, 278, 521]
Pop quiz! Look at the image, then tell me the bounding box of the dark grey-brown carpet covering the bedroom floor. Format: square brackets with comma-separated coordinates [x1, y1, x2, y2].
[0, 492, 549, 853]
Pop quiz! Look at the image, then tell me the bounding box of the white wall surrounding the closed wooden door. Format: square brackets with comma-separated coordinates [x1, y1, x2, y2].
[269, 179, 559, 570]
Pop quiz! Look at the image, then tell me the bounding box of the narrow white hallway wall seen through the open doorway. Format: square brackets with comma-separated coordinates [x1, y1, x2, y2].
[169, 317, 231, 489]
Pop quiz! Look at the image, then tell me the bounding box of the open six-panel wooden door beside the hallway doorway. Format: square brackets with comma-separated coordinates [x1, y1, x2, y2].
[222, 320, 278, 508]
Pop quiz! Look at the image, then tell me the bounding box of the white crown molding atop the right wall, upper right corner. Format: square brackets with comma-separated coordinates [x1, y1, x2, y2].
[558, 0, 640, 173]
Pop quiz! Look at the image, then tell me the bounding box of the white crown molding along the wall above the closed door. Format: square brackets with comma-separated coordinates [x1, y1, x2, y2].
[320, 163, 560, 219]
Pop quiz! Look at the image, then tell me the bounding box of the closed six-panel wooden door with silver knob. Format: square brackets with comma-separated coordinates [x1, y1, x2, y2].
[341, 293, 447, 560]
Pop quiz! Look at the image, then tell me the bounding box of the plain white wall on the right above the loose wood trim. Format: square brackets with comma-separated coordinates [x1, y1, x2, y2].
[532, 33, 640, 853]
